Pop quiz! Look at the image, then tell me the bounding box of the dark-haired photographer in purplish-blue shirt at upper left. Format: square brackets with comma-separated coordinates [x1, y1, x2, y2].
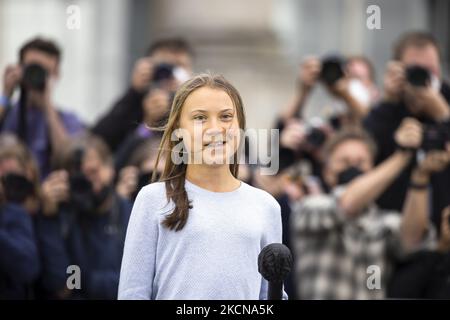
[0, 38, 83, 177]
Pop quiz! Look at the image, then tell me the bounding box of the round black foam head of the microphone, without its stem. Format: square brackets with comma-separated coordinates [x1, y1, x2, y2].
[258, 243, 293, 281]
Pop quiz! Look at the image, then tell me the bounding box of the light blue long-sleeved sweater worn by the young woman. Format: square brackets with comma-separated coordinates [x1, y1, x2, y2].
[118, 180, 281, 300]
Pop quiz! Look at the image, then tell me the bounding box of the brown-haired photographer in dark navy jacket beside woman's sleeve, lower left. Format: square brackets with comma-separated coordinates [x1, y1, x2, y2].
[36, 136, 131, 299]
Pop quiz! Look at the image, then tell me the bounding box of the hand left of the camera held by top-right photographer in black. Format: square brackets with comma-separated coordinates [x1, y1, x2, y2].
[383, 61, 405, 101]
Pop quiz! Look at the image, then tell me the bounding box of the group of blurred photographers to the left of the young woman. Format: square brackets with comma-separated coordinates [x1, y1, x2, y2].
[0, 38, 192, 299]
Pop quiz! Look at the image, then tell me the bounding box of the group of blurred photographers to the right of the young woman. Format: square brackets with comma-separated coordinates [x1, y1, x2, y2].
[272, 32, 450, 299]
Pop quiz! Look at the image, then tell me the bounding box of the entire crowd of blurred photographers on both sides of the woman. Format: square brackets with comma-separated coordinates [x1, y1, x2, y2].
[0, 32, 450, 299]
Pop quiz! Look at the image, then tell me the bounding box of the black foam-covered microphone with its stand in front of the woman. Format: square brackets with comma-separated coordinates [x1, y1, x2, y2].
[258, 243, 292, 300]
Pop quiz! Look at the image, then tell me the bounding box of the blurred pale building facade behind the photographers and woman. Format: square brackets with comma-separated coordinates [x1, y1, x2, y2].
[0, 0, 450, 128]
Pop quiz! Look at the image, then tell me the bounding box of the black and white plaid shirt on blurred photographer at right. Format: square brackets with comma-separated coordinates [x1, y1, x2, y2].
[291, 189, 435, 299]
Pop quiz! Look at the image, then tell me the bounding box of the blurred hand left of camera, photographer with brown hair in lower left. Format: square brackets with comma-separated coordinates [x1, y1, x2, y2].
[41, 170, 69, 216]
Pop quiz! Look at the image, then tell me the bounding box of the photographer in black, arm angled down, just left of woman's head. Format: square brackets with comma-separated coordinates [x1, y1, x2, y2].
[92, 38, 193, 153]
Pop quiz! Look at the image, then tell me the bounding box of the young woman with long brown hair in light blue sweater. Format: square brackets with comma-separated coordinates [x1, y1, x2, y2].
[118, 74, 281, 300]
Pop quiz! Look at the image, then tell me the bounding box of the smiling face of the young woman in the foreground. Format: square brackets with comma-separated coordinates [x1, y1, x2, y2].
[178, 87, 243, 166]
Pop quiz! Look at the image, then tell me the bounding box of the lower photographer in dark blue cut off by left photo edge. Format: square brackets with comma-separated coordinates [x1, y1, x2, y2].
[0, 134, 40, 299]
